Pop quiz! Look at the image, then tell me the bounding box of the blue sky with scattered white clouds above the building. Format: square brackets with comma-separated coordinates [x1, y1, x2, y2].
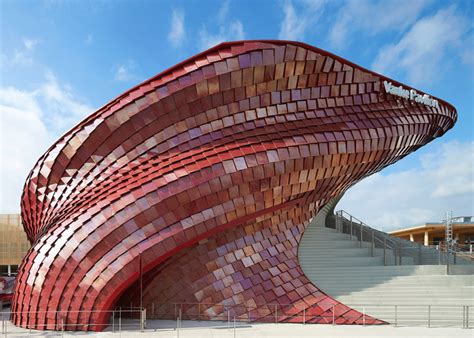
[0, 0, 474, 230]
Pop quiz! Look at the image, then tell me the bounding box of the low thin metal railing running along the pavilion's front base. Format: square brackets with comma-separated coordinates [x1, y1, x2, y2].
[0, 302, 473, 336]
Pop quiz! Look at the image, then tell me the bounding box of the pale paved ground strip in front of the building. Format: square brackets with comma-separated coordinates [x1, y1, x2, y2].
[3, 320, 474, 338]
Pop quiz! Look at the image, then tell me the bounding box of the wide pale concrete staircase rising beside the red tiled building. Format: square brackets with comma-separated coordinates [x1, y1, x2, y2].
[298, 219, 474, 327]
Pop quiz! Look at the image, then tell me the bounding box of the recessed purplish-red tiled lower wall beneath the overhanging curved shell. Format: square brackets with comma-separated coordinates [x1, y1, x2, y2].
[118, 206, 380, 324]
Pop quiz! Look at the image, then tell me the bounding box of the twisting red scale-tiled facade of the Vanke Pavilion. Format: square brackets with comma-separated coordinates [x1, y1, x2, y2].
[13, 41, 456, 330]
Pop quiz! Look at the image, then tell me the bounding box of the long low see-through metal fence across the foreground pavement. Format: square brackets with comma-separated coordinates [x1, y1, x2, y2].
[1, 303, 474, 336]
